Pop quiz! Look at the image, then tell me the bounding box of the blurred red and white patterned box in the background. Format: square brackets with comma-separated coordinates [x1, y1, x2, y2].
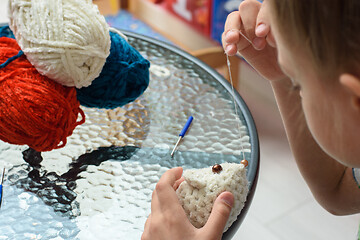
[165, 0, 213, 36]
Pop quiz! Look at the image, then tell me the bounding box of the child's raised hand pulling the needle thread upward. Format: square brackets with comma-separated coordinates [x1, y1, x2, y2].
[222, 0, 286, 80]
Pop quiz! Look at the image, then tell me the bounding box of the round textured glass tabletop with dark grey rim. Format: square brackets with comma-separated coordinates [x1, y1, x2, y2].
[0, 28, 259, 240]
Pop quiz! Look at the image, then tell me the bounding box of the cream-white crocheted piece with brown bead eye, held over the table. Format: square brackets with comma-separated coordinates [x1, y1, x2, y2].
[176, 163, 249, 232]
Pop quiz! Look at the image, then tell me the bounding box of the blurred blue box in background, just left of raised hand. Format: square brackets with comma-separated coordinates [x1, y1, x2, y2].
[210, 0, 262, 44]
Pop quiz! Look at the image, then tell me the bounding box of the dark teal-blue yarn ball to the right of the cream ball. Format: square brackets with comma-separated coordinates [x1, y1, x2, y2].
[76, 32, 150, 109]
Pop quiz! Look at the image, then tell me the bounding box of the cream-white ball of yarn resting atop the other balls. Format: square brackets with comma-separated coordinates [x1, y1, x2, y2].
[9, 0, 110, 88]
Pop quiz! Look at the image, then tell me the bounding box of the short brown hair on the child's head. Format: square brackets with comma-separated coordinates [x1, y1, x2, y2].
[270, 0, 360, 77]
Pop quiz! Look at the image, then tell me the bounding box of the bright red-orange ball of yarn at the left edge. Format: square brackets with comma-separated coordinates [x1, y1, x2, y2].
[0, 37, 85, 151]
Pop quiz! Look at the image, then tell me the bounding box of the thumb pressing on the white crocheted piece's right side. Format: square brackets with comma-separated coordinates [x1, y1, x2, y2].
[203, 192, 234, 239]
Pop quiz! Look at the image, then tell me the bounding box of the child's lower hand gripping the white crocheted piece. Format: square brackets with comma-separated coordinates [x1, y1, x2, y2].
[141, 167, 234, 240]
